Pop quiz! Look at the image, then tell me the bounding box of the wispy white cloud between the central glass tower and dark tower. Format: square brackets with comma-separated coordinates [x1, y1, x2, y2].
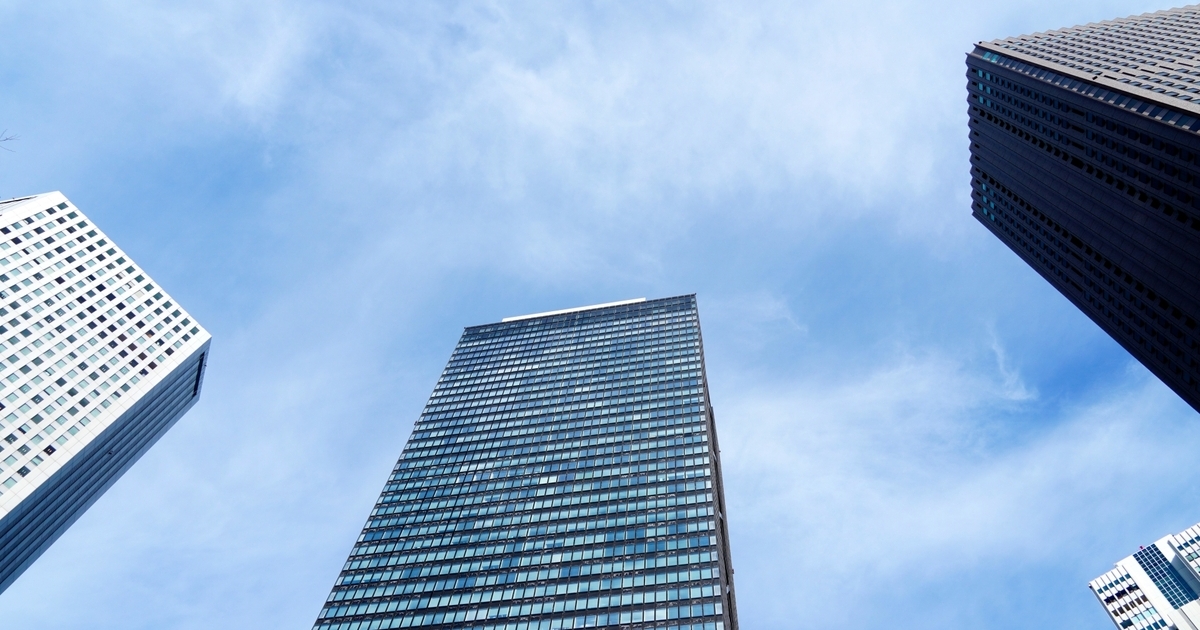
[719, 356, 1200, 628]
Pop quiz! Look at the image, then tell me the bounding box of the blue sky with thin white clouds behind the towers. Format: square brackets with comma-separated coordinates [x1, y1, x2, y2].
[0, 0, 1200, 630]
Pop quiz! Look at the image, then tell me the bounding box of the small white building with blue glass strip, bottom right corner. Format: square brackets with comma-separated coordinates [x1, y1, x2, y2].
[1088, 524, 1200, 630]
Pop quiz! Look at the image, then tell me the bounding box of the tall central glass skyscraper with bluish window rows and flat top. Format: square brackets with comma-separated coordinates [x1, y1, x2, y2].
[314, 295, 737, 630]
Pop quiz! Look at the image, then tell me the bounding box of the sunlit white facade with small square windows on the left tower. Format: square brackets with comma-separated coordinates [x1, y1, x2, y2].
[0, 196, 208, 517]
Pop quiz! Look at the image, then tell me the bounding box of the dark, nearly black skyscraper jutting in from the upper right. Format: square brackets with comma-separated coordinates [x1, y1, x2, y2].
[967, 6, 1200, 410]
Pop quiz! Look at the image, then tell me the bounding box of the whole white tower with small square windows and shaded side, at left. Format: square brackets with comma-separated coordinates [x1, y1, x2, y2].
[0, 192, 209, 590]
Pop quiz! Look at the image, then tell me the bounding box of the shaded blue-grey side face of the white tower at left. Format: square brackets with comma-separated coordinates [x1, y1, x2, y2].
[0, 342, 209, 592]
